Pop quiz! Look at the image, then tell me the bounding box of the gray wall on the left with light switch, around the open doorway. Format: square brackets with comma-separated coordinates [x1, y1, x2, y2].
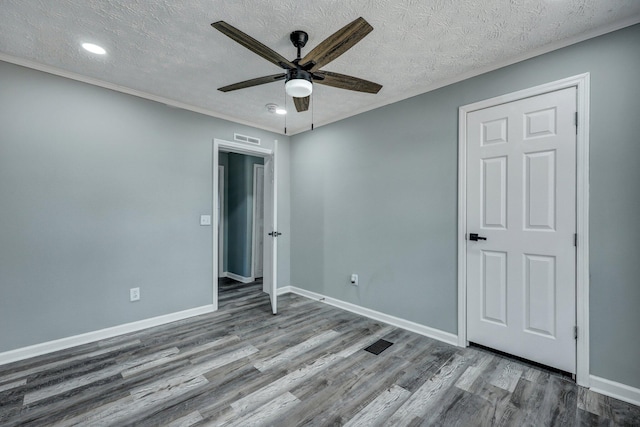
[0, 62, 290, 352]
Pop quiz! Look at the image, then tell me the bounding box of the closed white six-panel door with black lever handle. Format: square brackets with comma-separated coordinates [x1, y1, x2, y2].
[466, 87, 576, 373]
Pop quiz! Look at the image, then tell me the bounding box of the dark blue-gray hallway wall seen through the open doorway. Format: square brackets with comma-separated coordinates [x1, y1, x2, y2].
[225, 153, 264, 277]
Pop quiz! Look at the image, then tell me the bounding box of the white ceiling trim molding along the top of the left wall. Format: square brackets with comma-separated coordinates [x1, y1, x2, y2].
[0, 52, 289, 136]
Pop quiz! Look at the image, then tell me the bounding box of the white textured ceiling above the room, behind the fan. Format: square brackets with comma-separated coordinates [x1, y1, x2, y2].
[0, 0, 640, 134]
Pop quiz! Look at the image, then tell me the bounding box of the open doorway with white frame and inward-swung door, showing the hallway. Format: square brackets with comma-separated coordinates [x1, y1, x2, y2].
[213, 140, 278, 314]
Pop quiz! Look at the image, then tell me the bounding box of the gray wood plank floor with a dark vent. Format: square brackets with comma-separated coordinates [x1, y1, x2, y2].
[0, 281, 640, 426]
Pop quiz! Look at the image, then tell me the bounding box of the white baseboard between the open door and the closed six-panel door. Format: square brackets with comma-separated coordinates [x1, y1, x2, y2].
[278, 286, 458, 346]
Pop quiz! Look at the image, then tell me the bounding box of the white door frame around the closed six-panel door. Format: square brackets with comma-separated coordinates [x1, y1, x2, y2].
[457, 73, 590, 387]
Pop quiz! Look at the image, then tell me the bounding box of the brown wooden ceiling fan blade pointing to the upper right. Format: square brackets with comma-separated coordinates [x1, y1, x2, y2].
[300, 17, 373, 71]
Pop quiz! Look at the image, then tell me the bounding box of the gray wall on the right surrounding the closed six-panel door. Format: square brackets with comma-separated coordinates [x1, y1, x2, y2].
[291, 25, 640, 387]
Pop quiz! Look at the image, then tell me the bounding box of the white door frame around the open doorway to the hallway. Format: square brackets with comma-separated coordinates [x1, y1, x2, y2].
[211, 138, 277, 311]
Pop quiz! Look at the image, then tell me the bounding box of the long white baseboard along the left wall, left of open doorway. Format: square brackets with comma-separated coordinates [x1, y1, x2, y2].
[0, 304, 215, 365]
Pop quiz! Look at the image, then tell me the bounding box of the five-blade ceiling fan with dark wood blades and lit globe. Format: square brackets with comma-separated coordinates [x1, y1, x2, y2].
[211, 17, 382, 112]
